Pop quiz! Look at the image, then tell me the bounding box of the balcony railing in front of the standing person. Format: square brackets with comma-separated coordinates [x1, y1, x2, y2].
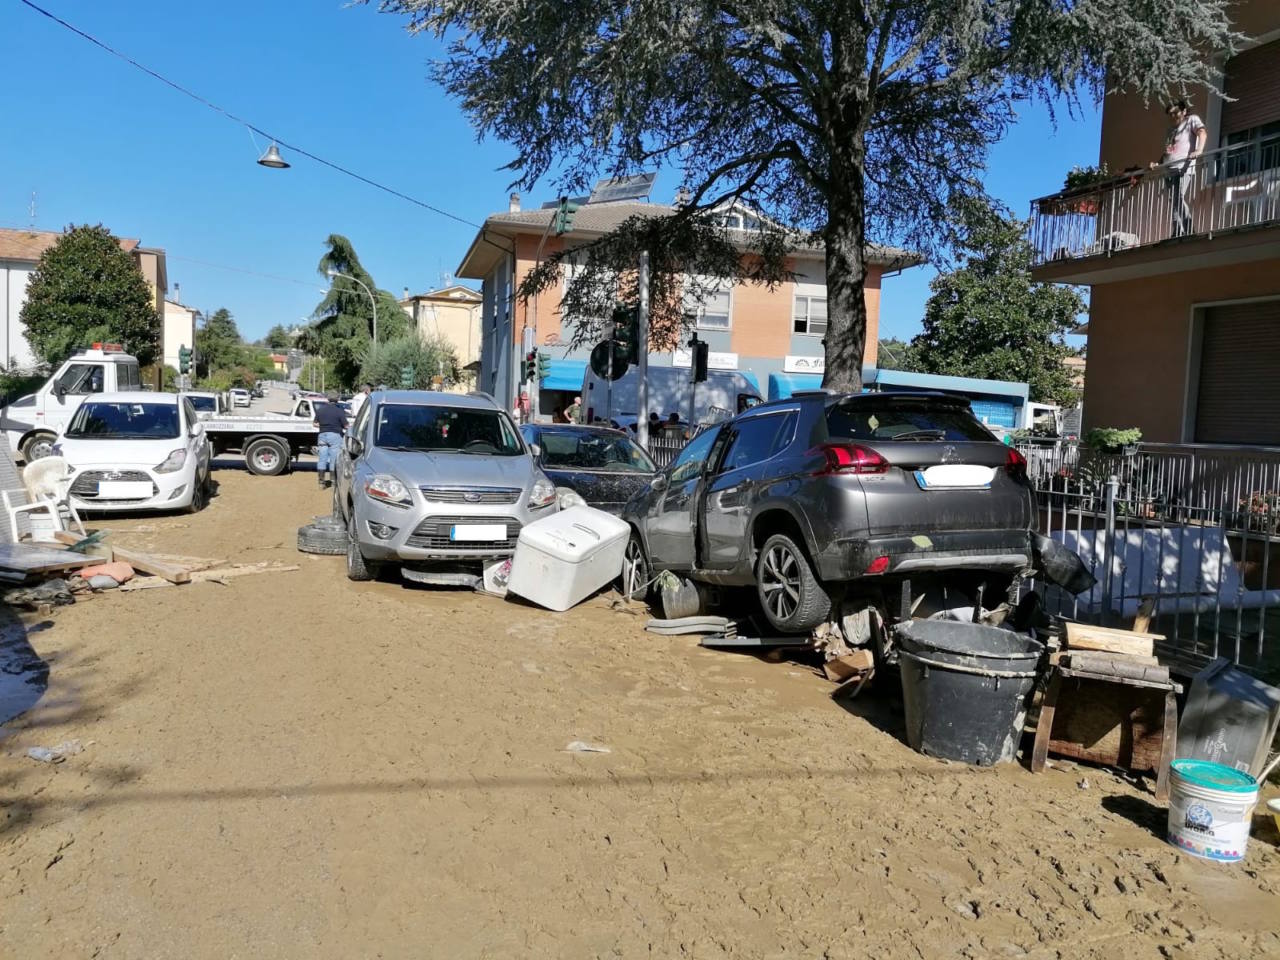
[1030, 134, 1280, 265]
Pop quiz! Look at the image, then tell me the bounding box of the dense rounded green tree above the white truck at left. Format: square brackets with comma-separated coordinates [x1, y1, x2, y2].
[22, 224, 160, 366]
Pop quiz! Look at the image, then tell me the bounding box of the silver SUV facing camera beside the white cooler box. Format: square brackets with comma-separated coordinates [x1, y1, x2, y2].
[334, 390, 557, 582]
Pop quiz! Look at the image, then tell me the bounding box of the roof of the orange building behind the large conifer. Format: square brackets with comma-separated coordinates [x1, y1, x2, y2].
[456, 201, 924, 280]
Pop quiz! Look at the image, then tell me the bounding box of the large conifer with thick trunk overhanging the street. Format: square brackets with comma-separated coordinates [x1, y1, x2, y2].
[380, 0, 1238, 389]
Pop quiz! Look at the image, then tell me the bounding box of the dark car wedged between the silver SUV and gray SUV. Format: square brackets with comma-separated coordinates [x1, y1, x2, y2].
[520, 424, 658, 515]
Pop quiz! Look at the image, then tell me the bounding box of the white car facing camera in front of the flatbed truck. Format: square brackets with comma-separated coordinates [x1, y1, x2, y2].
[54, 392, 210, 513]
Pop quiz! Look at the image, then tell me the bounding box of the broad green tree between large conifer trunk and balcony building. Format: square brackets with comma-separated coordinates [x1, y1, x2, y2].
[911, 201, 1085, 404]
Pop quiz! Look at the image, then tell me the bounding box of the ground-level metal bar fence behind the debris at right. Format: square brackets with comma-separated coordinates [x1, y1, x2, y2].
[1019, 442, 1280, 681]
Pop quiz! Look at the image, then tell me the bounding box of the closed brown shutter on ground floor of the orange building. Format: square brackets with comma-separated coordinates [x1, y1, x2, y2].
[1196, 300, 1280, 445]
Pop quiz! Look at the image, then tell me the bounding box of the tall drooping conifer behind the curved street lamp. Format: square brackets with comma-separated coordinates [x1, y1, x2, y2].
[298, 233, 410, 389]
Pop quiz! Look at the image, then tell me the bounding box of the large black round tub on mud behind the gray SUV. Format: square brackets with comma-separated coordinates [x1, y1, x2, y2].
[895, 620, 1044, 767]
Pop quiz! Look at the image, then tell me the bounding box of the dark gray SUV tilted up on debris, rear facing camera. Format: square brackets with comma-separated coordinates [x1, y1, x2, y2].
[622, 393, 1037, 632]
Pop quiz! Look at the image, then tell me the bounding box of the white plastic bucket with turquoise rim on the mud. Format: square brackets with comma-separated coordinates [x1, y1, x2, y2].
[1169, 760, 1258, 863]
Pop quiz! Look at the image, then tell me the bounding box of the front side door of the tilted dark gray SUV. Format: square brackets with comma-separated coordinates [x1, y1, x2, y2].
[701, 408, 795, 568]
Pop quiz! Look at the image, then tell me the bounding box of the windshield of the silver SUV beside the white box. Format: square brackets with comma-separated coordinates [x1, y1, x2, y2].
[374, 403, 525, 457]
